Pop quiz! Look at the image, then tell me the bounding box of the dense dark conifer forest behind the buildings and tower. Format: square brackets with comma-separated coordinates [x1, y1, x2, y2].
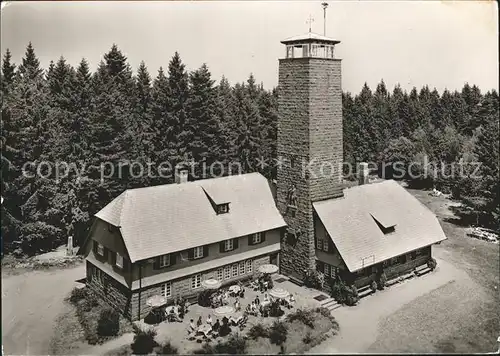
[1, 43, 499, 255]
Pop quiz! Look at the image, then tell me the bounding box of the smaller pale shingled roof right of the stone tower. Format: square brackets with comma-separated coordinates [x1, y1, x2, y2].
[313, 180, 446, 272]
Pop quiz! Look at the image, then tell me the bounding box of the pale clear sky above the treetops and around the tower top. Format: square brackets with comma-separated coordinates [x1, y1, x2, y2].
[1, 0, 499, 93]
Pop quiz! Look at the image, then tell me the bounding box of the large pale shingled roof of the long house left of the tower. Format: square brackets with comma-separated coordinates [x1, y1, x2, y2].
[95, 173, 286, 262]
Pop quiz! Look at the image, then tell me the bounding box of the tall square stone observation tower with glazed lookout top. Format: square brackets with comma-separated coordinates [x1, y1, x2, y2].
[277, 32, 342, 280]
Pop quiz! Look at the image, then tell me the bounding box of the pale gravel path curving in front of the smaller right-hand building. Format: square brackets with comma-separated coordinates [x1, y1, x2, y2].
[307, 260, 474, 354]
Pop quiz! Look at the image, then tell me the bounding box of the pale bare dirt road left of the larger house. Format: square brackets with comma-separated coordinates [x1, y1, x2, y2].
[2, 264, 85, 355]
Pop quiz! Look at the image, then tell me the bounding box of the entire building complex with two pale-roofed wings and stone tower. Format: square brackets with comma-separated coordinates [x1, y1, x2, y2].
[81, 33, 446, 320]
